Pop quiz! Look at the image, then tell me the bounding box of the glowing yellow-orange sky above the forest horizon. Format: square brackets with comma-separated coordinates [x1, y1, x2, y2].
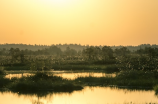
[0, 0, 158, 46]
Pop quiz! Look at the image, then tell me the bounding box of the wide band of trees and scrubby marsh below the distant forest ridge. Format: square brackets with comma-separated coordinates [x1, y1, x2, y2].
[0, 45, 158, 70]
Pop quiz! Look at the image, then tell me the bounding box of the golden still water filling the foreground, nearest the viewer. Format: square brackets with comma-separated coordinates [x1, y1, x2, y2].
[0, 87, 158, 104]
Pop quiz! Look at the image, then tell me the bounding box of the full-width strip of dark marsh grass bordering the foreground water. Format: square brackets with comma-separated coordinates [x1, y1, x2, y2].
[0, 70, 158, 93]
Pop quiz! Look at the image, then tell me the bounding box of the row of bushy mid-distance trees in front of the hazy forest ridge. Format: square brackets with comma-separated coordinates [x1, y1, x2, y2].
[0, 46, 158, 62]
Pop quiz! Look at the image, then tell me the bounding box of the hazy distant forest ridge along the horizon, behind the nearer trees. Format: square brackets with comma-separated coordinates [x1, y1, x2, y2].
[0, 44, 158, 51]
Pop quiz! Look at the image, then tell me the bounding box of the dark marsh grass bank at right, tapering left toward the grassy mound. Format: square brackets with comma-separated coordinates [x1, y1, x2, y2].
[75, 70, 158, 88]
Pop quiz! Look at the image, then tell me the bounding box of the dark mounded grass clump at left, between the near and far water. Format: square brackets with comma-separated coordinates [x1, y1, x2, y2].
[9, 72, 82, 92]
